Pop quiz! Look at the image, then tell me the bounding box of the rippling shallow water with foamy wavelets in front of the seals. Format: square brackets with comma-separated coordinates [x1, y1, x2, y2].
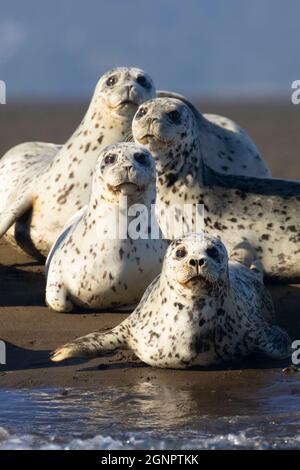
[0, 382, 300, 449]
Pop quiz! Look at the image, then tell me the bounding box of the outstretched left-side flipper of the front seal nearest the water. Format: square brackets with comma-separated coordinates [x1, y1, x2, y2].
[50, 320, 129, 362]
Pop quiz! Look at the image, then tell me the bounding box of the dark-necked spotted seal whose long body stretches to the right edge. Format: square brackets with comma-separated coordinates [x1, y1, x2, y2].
[133, 98, 300, 282]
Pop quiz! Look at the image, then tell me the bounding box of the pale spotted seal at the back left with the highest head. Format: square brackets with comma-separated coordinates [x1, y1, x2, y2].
[0, 67, 156, 257]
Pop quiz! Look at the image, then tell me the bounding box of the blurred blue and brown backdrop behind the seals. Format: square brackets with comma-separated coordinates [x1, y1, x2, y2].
[0, 0, 300, 178]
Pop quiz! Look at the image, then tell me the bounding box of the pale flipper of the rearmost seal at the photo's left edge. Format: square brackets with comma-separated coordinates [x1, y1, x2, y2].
[0, 190, 32, 238]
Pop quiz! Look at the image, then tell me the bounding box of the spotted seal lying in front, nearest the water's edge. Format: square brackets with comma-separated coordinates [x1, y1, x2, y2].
[51, 234, 291, 369]
